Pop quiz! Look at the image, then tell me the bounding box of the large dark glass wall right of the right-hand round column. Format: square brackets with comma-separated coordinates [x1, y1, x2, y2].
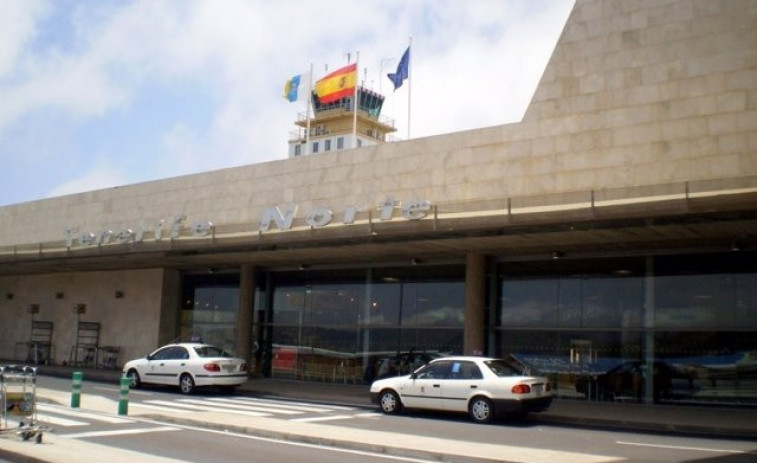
[494, 253, 757, 403]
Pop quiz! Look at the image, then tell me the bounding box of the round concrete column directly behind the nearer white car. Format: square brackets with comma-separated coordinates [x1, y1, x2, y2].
[463, 253, 486, 355]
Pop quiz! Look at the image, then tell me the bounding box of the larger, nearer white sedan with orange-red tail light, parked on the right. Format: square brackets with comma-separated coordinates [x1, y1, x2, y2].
[371, 357, 552, 423]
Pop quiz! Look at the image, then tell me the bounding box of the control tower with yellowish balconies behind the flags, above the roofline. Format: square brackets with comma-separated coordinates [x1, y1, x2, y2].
[289, 86, 397, 158]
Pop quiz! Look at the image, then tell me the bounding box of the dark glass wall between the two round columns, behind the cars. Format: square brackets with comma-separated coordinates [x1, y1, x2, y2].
[263, 266, 465, 383]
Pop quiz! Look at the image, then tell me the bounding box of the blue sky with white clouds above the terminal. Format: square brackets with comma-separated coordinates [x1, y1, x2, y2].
[0, 0, 574, 206]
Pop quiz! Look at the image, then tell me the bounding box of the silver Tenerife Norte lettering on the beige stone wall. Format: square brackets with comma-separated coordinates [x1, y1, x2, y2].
[63, 196, 431, 249]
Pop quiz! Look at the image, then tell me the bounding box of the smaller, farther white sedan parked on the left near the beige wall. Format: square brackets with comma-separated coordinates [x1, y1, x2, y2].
[123, 343, 248, 394]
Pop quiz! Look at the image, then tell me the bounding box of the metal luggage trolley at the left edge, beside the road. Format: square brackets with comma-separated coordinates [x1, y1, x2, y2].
[0, 365, 50, 443]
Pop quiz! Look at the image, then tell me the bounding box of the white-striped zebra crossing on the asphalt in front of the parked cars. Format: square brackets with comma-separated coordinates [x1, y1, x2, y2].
[36, 397, 380, 429]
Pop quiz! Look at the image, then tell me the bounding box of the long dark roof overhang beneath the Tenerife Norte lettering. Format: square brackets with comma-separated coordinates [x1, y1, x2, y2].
[0, 187, 757, 275]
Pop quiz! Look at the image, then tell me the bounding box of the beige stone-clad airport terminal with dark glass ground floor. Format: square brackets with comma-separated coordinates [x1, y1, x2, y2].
[0, 0, 757, 405]
